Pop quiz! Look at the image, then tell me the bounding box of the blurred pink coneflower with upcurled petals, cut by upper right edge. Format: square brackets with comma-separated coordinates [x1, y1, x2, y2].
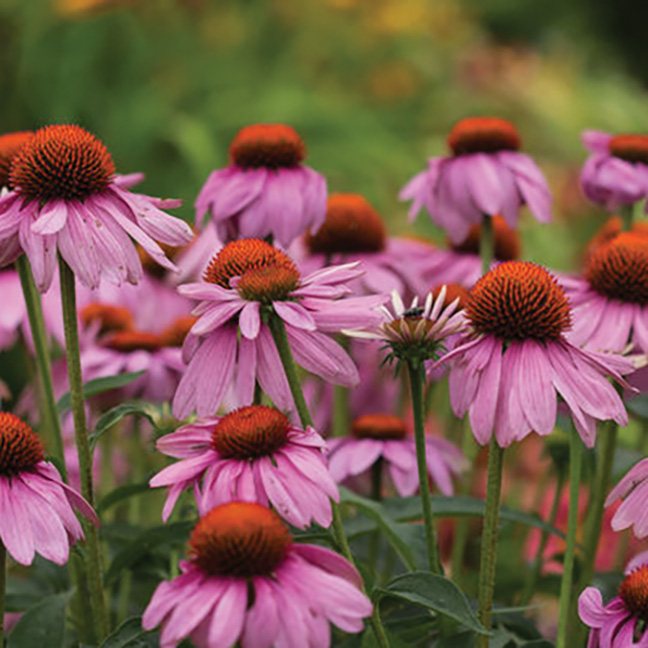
[580, 130, 648, 211]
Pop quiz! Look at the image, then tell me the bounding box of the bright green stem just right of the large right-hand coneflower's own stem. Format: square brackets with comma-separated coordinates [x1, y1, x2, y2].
[556, 429, 583, 648]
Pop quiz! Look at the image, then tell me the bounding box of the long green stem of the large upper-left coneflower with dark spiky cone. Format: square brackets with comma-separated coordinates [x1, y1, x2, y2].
[59, 258, 109, 642]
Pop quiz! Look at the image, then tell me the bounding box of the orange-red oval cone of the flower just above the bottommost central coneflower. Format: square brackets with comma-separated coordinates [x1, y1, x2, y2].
[212, 405, 292, 460]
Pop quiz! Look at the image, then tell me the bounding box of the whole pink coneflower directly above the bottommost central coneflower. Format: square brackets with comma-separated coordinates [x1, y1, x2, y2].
[151, 405, 339, 528]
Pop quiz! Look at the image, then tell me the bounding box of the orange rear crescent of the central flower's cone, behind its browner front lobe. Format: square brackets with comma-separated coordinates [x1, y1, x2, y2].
[203, 239, 299, 288]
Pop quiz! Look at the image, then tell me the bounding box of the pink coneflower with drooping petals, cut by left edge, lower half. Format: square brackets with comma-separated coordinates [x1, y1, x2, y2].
[0, 412, 99, 565]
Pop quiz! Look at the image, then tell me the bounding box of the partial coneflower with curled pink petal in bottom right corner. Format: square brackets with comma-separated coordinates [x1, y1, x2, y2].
[578, 556, 648, 648]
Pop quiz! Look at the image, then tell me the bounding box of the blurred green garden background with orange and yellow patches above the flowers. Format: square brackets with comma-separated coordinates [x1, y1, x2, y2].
[0, 0, 648, 269]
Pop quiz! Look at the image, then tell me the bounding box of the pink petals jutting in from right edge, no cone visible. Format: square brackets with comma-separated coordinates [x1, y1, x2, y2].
[605, 459, 648, 538]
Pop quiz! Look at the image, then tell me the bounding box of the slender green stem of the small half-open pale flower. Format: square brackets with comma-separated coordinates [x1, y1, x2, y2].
[407, 362, 442, 574]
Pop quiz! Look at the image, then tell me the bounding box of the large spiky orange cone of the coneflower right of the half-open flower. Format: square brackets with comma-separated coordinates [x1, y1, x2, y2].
[466, 261, 571, 341]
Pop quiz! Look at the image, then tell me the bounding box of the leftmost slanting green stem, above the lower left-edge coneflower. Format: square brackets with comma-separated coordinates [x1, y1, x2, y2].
[15, 254, 67, 476]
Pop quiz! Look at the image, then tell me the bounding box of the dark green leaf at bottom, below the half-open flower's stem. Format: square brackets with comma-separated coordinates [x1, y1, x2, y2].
[374, 572, 489, 634]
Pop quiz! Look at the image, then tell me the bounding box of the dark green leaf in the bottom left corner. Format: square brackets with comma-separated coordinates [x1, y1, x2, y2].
[7, 592, 72, 648]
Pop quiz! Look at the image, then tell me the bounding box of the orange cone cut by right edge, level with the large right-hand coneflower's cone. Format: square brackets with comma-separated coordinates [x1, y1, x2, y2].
[585, 232, 648, 306]
